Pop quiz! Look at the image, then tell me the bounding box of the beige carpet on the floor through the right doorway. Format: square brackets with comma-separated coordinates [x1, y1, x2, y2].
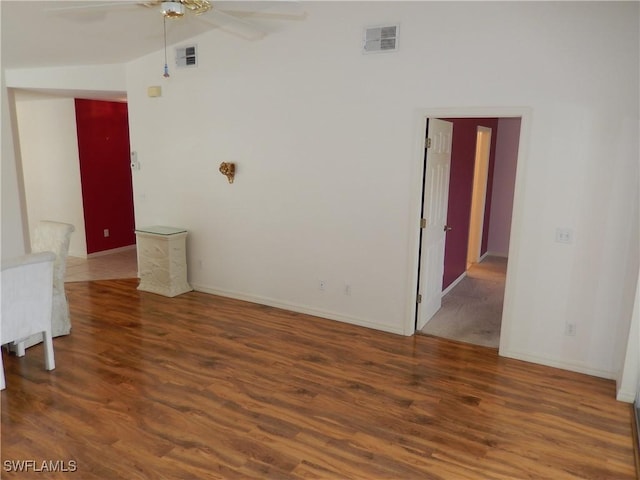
[421, 257, 507, 348]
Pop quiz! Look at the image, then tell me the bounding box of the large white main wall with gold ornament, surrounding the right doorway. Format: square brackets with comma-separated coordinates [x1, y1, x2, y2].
[127, 2, 638, 378]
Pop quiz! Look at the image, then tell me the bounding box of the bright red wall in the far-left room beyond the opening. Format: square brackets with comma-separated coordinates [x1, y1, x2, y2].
[75, 99, 136, 254]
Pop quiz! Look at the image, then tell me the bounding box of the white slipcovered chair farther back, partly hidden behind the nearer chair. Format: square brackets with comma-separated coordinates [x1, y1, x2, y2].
[11, 220, 75, 357]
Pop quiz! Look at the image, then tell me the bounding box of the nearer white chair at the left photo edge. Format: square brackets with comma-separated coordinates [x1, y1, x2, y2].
[0, 252, 56, 390]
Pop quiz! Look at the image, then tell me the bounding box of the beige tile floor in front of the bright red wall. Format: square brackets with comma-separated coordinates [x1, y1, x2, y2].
[65, 248, 138, 282]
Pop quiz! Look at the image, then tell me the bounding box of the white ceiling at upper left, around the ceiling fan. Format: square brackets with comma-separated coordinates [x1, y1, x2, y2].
[0, 0, 304, 68]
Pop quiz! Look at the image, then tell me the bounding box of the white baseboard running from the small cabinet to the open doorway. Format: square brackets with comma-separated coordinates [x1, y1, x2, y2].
[191, 283, 403, 335]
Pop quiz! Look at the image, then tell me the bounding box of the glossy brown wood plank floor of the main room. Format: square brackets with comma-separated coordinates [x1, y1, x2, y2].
[1, 280, 635, 480]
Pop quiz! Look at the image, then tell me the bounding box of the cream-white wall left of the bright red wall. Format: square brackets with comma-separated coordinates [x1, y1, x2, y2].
[16, 92, 87, 257]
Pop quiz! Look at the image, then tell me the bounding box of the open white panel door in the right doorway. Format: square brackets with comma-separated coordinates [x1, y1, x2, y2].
[417, 118, 453, 330]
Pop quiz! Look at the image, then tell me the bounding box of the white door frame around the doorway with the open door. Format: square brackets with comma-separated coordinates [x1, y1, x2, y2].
[404, 107, 532, 360]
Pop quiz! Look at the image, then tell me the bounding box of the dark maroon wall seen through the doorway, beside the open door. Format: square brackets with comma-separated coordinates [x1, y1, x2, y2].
[442, 118, 498, 289]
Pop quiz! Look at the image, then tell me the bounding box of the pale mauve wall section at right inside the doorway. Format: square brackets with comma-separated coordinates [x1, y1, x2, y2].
[487, 118, 521, 257]
